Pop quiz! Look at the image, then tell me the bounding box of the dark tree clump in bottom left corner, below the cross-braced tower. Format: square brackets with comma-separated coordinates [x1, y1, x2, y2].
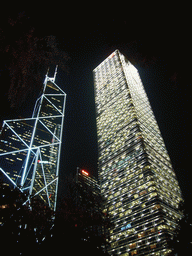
[0, 184, 54, 255]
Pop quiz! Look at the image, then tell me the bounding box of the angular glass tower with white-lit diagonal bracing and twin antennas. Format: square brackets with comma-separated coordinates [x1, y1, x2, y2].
[0, 68, 66, 210]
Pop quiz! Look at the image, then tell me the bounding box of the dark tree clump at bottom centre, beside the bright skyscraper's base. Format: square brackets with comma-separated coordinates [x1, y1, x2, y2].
[55, 177, 112, 255]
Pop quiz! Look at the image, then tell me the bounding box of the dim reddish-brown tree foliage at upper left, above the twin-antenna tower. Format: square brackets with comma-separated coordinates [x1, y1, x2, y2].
[0, 12, 69, 107]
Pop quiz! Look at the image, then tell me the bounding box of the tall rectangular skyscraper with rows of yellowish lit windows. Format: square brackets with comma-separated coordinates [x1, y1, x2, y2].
[93, 50, 182, 256]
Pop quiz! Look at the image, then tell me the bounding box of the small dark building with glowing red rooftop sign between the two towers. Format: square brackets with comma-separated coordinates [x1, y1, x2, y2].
[75, 168, 110, 251]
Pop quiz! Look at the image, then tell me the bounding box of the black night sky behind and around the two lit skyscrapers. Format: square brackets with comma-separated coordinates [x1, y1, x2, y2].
[0, 7, 192, 204]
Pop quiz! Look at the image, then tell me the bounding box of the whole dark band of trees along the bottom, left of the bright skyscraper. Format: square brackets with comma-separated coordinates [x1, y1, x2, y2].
[0, 178, 111, 256]
